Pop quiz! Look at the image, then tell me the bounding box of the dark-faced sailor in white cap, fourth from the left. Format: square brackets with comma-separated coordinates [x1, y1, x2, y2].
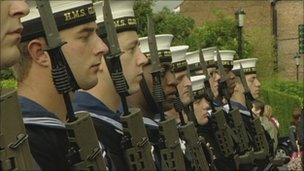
[129, 34, 186, 168]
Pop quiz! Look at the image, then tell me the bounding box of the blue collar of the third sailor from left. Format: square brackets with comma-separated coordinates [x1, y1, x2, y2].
[73, 91, 120, 121]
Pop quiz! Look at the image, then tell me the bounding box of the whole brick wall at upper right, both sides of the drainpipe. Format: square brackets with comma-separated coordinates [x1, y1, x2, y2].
[180, 0, 304, 80]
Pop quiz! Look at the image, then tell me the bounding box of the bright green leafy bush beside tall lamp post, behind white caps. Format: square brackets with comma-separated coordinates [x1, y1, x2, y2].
[186, 10, 252, 57]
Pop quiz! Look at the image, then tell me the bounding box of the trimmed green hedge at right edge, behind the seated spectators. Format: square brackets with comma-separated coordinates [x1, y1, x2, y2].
[262, 80, 304, 136]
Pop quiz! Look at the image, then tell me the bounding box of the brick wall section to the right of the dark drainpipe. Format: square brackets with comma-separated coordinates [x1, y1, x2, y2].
[277, 1, 304, 80]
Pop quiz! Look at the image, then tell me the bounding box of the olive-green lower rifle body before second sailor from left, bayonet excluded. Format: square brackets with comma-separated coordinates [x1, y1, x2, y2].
[65, 112, 106, 170]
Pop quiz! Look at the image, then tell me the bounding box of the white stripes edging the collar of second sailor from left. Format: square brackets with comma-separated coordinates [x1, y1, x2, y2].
[23, 117, 65, 128]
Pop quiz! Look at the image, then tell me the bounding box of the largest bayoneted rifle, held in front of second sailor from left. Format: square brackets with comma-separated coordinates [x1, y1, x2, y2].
[36, 0, 106, 170]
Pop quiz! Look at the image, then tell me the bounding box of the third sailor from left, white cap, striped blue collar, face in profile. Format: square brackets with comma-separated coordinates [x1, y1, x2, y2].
[74, 0, 151, 170]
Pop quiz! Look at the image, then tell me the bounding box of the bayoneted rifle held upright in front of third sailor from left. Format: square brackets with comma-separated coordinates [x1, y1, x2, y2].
[103, 0, 156, 170]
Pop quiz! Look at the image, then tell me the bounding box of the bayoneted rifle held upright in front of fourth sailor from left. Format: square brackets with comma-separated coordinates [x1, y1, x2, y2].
[147, 16, 186, 170]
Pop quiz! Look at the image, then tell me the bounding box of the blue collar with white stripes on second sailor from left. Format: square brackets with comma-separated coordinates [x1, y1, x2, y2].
[18, 96, 65, 128]
